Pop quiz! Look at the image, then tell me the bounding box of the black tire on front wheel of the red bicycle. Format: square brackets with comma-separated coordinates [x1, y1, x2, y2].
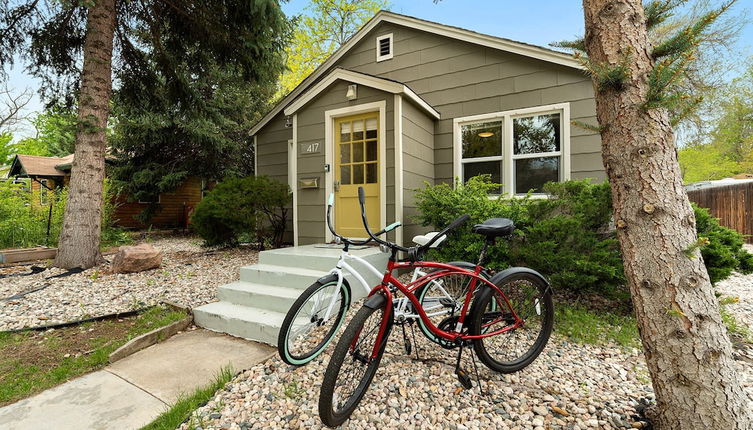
[319, 294, 393, 427]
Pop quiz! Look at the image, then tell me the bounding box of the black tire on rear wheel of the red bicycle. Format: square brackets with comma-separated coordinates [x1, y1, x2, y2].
[469, 272, 554, 373]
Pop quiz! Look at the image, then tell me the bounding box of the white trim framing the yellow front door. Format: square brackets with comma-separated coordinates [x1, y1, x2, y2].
[322, 100, 387, 242]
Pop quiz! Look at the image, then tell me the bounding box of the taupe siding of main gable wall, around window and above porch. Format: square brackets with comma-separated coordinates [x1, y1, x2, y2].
[338, 23, 605, 182]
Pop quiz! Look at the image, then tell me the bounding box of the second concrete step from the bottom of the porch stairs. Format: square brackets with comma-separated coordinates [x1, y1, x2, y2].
[217, 281, 303, 313]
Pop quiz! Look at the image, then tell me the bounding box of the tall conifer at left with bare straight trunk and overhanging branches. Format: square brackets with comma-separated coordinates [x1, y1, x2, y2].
[0, 0, 289, 268]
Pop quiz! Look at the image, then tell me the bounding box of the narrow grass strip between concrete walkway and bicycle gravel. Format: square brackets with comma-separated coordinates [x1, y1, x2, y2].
[141, 367, 235, 430]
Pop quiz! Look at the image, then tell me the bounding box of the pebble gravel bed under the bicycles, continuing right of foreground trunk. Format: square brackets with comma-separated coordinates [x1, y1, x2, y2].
[180, 247, 753, 430]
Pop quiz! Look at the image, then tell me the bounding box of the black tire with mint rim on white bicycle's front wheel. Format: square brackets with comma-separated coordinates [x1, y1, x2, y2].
[277, 275, 351, 366]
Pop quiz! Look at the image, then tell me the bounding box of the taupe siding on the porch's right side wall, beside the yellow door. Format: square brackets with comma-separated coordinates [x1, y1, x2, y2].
[402, 98, 434, 244]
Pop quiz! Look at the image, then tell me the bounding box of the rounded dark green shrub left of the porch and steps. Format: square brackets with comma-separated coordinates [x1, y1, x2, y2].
[191, 176, 290, 247]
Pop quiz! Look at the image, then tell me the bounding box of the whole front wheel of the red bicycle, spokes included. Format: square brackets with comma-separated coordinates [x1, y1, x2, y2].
[319, 296, 392, 427]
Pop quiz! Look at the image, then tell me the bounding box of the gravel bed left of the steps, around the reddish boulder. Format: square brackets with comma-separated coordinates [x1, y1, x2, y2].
[0, 236, 258, 330]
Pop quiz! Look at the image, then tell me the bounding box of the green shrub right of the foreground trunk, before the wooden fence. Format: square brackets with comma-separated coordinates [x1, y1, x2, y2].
[693, 204, 753, 283]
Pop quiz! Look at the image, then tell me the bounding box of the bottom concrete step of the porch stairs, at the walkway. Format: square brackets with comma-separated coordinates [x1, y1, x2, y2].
[193, 302, 285, 346]
